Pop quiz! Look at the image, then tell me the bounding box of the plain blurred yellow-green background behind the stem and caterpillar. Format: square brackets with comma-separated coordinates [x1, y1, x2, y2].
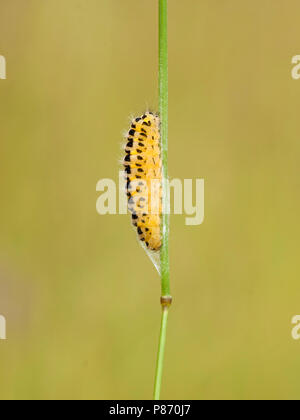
[0, 0, 300, 399]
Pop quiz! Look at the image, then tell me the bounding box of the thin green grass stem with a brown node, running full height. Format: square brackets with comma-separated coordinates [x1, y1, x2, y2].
[154, 0, 172, 400]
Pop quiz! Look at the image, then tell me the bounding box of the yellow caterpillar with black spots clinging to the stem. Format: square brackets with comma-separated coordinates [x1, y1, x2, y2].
[123, 112, 162, 251]
